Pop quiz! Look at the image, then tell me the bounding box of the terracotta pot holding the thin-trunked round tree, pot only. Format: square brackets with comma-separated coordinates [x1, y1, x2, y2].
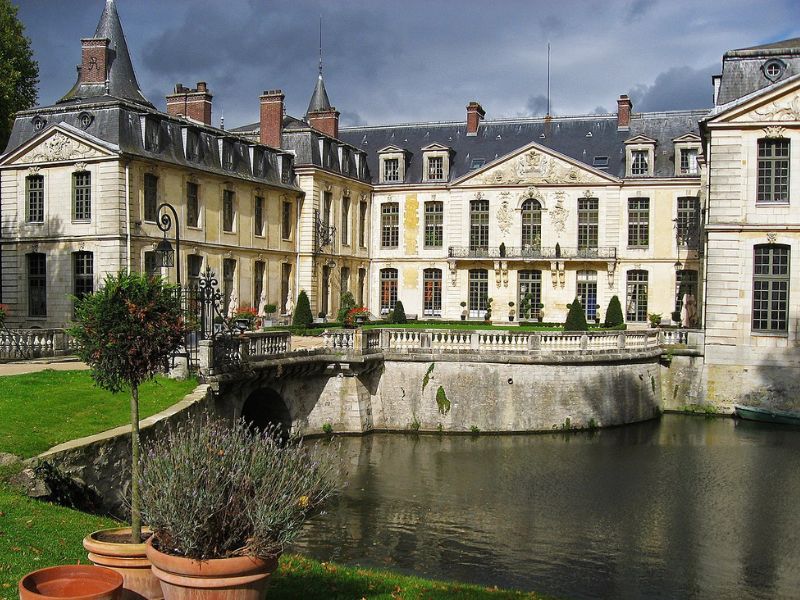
[83, 527, 164, 600]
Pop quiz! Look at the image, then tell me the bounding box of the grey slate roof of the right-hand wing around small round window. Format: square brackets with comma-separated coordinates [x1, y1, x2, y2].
[716, 38, 800, 105]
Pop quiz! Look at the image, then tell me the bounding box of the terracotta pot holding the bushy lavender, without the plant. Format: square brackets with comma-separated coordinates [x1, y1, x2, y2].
[146, 538, 278, 600]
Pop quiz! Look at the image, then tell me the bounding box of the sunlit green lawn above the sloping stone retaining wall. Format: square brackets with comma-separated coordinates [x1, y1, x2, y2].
[0, 371, 197, 458]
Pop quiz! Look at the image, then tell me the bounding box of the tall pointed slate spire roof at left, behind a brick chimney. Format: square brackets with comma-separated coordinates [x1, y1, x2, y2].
[58, 0, 154, 108]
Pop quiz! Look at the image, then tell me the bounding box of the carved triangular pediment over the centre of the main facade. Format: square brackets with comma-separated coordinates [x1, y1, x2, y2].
[473, 148, 602, 186]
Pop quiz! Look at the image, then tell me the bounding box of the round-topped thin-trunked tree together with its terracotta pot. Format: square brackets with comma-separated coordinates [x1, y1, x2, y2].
[69, 272, 187, 598]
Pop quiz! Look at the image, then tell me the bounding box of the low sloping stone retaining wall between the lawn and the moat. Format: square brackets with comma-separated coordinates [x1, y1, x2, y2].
[38, 385, 214, 517]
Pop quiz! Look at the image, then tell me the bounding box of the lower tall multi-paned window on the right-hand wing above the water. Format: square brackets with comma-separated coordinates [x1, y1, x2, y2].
[753, 244, 789, 331]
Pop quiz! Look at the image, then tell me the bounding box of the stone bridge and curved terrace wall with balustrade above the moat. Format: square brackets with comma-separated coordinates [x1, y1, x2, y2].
[199, 329, 703, 435]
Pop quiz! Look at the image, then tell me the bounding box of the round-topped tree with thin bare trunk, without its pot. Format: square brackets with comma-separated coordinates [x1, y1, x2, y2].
[69, 272, 187, 543]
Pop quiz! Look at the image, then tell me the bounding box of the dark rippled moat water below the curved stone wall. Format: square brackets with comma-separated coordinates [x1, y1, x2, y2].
[293, 415, 800, 599]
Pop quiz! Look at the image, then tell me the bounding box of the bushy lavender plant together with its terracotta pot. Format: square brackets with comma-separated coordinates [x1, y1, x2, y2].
[141, 417, 337, 600]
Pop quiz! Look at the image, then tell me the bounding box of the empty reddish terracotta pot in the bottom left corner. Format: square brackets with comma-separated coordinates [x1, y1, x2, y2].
[19, 565, 122, 600]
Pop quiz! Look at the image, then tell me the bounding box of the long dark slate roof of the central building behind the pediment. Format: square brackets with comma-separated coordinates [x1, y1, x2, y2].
[339, 110, 708, 184]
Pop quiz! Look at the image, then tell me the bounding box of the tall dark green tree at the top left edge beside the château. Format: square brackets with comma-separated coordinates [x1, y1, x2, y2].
[0, 0, 39, 152]
